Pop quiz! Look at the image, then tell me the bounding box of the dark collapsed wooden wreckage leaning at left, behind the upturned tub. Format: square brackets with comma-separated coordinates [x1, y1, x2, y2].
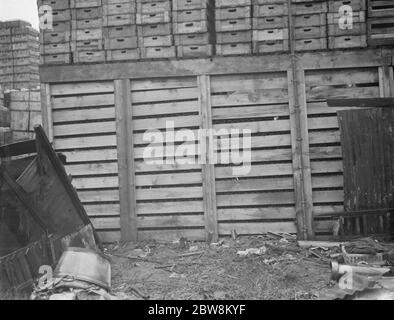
[0, 126, 101, 298]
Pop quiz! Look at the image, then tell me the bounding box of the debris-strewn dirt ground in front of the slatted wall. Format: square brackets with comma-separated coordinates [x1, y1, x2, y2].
[106, 236, 330, 300]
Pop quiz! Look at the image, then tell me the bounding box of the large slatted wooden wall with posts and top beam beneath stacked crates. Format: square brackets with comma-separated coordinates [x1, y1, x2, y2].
[40, 49, 393, 242]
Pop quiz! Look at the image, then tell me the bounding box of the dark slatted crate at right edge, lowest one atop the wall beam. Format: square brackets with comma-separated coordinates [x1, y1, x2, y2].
[367, 16, 394, 46]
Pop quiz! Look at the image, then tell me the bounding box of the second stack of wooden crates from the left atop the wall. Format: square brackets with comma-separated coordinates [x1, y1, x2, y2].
[71, 0, 105, 63]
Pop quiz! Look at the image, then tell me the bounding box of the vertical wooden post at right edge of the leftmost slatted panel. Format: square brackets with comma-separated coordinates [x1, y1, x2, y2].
[114, 79, 137, 241]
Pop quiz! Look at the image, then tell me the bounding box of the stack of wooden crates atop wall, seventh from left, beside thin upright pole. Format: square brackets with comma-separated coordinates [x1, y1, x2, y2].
[253, 0, 289, 53]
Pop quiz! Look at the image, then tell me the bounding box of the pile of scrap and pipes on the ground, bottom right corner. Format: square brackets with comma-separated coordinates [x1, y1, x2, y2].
[298, 237, 394, 300]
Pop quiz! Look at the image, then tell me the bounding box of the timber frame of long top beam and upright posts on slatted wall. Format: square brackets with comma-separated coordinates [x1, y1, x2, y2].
[40, 48, 394, 241]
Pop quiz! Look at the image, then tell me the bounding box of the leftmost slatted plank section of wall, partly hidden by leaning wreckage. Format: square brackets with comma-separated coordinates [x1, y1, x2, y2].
[51, 82, 120, 241]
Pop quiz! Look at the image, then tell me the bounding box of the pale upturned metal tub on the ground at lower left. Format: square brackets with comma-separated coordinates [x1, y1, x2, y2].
[55, 247, 111, 290]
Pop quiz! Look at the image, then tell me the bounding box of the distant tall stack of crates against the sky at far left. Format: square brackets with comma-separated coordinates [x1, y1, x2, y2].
[0, 20, 40, 90]
